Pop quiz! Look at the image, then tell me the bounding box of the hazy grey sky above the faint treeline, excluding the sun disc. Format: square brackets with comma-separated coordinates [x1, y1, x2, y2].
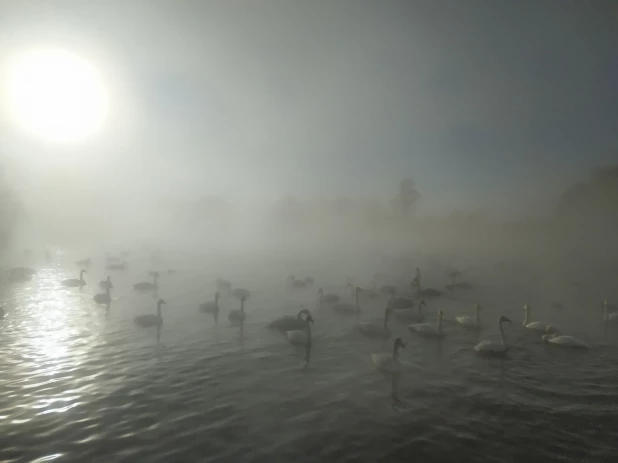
[0, 0, 618, 218]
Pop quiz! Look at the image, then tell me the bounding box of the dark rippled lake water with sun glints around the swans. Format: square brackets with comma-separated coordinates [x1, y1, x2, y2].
[0, 252, 618, 462]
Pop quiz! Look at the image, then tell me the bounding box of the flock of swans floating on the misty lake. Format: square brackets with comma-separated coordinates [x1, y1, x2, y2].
[0, 257, 618, 380]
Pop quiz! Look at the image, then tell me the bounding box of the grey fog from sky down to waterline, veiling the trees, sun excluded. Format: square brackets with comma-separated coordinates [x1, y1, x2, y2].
[0, 1, 617, 280]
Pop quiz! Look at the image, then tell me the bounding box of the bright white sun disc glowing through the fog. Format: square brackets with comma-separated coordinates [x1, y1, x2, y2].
[5, 49, 108, 143]
